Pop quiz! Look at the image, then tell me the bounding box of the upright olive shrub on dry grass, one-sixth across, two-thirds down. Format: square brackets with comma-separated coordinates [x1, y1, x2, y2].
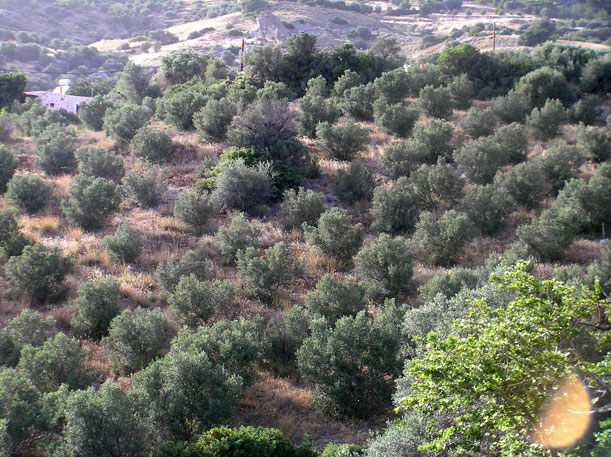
[70, 278, 121, 339]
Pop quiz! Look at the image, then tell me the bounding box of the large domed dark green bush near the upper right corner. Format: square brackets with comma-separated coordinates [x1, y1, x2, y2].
[516, 67, 575, 109]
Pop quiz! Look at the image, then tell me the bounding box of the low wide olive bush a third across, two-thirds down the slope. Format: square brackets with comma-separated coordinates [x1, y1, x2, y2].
[168, 274, 235, 327]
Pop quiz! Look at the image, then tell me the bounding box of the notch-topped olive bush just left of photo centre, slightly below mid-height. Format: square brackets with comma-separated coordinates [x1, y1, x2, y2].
[236, 242, 303, 304]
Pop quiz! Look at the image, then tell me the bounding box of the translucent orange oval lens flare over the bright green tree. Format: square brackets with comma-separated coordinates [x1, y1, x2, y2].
[530, 376, 592, 449]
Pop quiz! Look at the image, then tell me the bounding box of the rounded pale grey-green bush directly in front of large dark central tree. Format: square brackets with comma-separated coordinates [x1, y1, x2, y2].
[212, 159, 274, 212]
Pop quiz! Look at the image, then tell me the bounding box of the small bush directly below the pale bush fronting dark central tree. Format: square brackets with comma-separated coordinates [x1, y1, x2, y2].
[214, 213, 261, 264]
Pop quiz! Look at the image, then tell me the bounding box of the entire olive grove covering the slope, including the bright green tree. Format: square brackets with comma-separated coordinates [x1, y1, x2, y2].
[0, 33, 611, 457]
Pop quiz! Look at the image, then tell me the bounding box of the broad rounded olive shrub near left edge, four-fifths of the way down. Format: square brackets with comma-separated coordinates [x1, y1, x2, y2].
[17, 332, 96, 392]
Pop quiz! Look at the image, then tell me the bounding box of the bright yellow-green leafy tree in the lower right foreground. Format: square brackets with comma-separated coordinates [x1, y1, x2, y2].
[399, 264, 609, 457]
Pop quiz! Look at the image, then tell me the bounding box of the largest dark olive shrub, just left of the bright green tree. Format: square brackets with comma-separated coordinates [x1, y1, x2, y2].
[297, 305, 403, 418]
